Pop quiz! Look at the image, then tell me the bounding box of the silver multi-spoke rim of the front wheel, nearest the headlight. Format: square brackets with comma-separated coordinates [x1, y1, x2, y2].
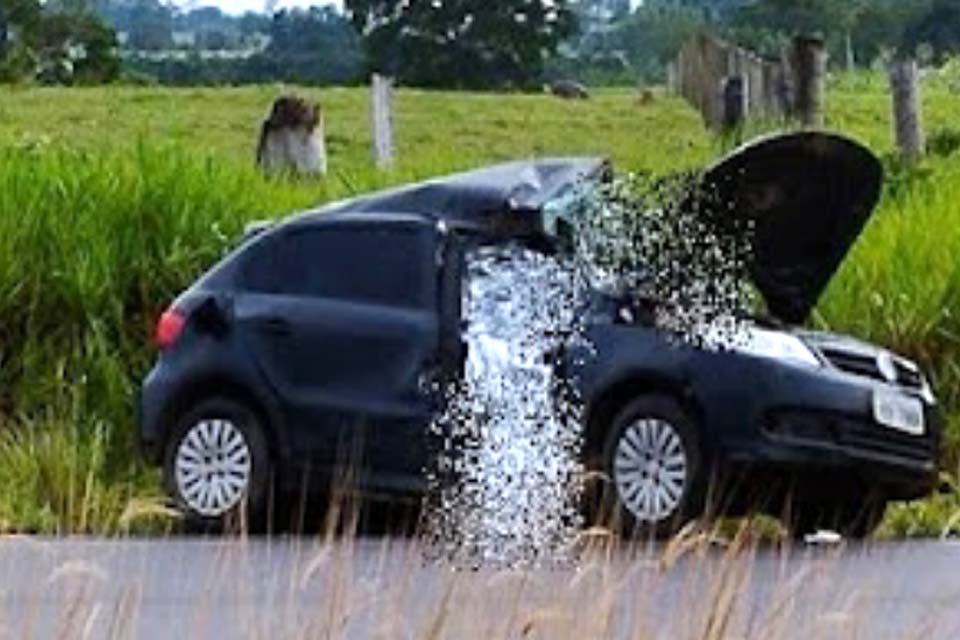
[613, 418, 687, 523]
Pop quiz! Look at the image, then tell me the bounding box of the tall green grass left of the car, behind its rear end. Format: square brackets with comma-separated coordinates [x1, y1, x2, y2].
[0, 145, 316, 531]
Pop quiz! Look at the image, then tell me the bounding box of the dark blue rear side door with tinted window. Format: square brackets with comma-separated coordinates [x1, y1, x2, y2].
[236, 219, 440, 485]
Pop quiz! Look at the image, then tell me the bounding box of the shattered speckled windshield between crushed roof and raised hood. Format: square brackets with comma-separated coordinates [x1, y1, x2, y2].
[543, 174, 756, 334]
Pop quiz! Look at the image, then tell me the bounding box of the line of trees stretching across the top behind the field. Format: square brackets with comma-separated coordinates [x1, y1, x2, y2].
[0, 0, 960, 90]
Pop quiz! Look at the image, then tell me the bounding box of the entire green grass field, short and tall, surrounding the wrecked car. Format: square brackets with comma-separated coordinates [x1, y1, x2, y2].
[0, 77, 960, 535]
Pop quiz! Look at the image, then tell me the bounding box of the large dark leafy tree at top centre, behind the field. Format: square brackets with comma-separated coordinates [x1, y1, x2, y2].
[346, 0, 575, 89]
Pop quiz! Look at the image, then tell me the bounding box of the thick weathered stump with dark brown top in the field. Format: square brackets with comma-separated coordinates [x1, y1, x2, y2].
[257, 96, 327, 175]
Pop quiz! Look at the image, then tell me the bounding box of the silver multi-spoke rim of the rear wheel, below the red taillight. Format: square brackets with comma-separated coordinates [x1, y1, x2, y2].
[174, 419, 252, 517]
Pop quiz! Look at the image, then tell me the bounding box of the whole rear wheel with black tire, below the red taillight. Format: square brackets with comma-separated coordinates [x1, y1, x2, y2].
[163, 397, 271, 531]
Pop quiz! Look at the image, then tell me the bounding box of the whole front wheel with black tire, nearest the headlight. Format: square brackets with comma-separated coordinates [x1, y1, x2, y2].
[598, 395, 706, 539]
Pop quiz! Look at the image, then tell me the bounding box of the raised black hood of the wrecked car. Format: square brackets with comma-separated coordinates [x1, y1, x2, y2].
[701, 132, 883, 324]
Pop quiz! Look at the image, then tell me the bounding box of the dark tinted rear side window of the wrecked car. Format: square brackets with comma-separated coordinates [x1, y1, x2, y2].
[252, 224, 435, 308]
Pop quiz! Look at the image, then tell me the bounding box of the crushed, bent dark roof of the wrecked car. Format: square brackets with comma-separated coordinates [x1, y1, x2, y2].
[291, 158, 609, 235]
